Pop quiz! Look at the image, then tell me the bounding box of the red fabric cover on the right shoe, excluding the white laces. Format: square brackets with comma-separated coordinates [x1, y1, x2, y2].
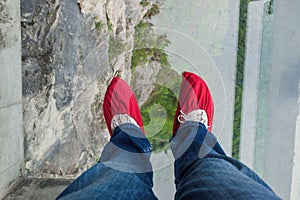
[173, 72, 214, 135]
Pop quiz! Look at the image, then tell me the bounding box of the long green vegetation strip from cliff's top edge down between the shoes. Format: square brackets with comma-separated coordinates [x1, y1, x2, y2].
[131, 4, 181, 151]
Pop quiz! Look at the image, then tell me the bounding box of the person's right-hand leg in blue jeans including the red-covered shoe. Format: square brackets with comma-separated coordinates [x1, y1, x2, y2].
[171, 72, 278, 199]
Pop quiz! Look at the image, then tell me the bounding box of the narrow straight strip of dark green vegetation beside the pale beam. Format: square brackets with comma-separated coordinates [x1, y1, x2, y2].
[232, 0, 249, 159]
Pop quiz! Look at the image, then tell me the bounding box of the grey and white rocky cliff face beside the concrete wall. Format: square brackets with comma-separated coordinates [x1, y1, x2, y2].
[21, 0, 151, 178]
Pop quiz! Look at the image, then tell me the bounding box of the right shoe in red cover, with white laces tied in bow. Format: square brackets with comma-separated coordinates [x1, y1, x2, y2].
[173, 72, 214, 135]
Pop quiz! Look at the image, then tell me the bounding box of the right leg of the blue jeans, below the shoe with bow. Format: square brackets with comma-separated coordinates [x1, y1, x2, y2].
[171, 122, 279, 200]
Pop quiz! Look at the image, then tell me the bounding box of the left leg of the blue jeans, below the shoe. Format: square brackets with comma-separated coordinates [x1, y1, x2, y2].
[57, 124, 157, 200]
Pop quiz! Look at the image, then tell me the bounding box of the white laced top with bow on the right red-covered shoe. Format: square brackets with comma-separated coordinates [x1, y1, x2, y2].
[177, 109, 209, 128]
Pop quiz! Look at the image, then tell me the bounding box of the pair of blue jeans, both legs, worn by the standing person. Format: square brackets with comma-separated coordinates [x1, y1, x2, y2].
[58, 122, 279, 200]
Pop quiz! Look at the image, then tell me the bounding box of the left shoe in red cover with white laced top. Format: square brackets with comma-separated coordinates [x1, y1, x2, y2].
[103, 77, 145, 136]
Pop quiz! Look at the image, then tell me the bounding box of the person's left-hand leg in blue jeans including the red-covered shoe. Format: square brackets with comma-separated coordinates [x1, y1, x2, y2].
[58, 77, 157, 199]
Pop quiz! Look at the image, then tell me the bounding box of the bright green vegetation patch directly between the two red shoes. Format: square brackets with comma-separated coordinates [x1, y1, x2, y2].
[141, 65, 181, 151]
